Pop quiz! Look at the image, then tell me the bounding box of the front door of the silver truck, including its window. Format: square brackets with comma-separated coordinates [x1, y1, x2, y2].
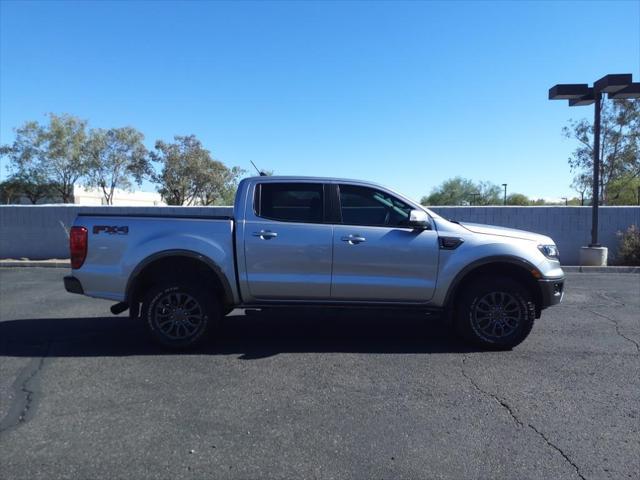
[331, 184, 439, 302]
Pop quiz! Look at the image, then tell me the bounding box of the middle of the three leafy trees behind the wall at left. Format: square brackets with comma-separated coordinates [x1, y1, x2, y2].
[86, 127, 151, 205]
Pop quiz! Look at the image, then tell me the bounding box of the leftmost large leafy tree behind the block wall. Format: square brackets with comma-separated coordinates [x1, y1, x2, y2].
[0, 113, 88, 203]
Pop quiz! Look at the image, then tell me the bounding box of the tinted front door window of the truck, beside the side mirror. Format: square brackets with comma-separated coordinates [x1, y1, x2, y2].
[340, 185, 411, 227]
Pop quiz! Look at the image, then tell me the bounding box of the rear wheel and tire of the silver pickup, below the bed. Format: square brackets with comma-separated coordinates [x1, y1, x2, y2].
[142, 283, 221, 350]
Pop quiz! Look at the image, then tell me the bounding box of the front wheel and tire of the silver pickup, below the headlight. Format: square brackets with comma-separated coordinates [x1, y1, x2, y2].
[454, 277, 535, 350]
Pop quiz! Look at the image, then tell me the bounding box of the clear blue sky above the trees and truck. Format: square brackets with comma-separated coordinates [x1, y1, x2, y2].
[0, 1, 640, 199]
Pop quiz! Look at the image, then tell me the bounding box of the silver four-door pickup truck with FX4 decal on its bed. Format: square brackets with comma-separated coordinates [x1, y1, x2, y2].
[64, 177, 564, 349]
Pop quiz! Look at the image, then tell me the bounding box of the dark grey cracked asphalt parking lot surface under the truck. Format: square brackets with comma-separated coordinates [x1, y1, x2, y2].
[0, 268, 640, 480]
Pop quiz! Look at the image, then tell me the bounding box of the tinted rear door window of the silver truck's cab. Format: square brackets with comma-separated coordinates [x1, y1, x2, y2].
[255, 183, 324, 223]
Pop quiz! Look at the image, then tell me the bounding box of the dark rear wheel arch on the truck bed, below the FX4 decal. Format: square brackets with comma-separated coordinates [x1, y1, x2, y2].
[125, 250, 233, 314]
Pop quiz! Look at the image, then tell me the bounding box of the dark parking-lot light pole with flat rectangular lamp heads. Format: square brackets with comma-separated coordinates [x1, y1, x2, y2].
[549, 73, 640, 247]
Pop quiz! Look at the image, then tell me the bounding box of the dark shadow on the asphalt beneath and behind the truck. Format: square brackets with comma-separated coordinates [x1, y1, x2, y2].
[0, 309, 474, 360]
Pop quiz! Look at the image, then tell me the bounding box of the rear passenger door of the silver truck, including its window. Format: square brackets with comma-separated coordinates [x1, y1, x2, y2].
[244, 181, 333, 300]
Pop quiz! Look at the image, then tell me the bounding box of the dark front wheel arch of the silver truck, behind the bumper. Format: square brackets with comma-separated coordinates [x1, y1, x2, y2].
[444, 256, 542, 318]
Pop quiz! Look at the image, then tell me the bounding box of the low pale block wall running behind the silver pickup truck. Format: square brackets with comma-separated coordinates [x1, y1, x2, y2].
[0, 205, 640, 265]
